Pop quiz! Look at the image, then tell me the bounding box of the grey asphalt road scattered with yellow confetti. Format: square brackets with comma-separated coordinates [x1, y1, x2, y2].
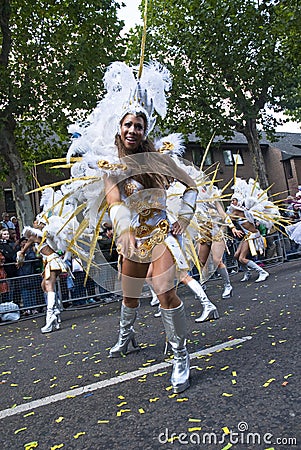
[0, 260, 301, 450]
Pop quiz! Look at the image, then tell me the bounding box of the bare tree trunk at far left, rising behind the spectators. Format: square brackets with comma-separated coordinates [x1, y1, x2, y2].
[0, 117, 34, 230]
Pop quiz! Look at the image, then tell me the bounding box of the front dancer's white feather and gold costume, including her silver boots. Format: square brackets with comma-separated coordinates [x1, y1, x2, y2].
[34, 62, 197, 392]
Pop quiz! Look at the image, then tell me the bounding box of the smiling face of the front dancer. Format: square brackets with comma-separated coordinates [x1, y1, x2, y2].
[120, 114, 145, 151]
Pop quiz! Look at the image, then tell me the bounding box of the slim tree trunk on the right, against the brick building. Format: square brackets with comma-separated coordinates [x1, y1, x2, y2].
[241, 119, 269, 189]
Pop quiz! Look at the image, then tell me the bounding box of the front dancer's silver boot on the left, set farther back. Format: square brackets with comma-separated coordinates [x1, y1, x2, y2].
[109, 303, 140, 358]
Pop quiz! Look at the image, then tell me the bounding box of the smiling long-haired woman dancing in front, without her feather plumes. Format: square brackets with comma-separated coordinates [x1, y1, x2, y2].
[105, 107, 197, 392]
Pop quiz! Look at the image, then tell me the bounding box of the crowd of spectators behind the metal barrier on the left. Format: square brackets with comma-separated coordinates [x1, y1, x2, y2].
[0, 212, 118, 321]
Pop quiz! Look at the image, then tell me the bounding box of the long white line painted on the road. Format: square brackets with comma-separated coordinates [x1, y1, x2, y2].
[0, 336, 252, 419]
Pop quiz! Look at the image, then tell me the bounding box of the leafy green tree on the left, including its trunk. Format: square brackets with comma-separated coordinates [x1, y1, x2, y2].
[0, 0, 124, 225]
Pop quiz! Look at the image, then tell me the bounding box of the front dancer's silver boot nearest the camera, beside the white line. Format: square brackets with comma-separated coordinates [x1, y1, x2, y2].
[161, 302, 190, 394]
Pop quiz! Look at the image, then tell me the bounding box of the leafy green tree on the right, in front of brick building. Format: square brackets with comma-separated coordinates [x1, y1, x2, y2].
[131, 0, 301, 187]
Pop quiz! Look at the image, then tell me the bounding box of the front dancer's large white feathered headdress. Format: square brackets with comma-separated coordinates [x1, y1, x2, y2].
[67, 61, 172, 163]
